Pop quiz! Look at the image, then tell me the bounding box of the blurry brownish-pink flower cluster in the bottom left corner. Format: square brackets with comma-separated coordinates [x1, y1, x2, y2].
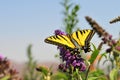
[0, 56, 21, 80]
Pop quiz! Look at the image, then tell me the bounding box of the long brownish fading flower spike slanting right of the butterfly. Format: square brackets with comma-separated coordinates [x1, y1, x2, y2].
[86, 16, 117, 52]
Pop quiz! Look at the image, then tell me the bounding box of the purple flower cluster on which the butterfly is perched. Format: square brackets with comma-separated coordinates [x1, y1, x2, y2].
[55, 30, 86, 72]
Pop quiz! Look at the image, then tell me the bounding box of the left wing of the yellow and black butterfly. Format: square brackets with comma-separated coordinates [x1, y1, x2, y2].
[45, 35, 75, 49]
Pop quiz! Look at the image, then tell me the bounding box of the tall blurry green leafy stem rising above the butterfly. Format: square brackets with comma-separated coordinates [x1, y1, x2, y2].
[61, 0, 79, 34]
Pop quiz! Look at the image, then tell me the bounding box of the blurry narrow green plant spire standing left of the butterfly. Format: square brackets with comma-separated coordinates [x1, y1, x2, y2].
[23, 44, 40, 80]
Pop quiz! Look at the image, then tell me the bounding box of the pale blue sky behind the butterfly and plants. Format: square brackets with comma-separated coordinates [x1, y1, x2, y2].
[0, 0, 120, 62]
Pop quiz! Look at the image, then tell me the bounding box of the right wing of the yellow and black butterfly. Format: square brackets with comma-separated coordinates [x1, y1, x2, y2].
[72, 29, 95, 52]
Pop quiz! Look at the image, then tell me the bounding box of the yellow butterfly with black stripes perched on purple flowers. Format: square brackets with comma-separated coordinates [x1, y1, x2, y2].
[45, 29, 95, 53]
